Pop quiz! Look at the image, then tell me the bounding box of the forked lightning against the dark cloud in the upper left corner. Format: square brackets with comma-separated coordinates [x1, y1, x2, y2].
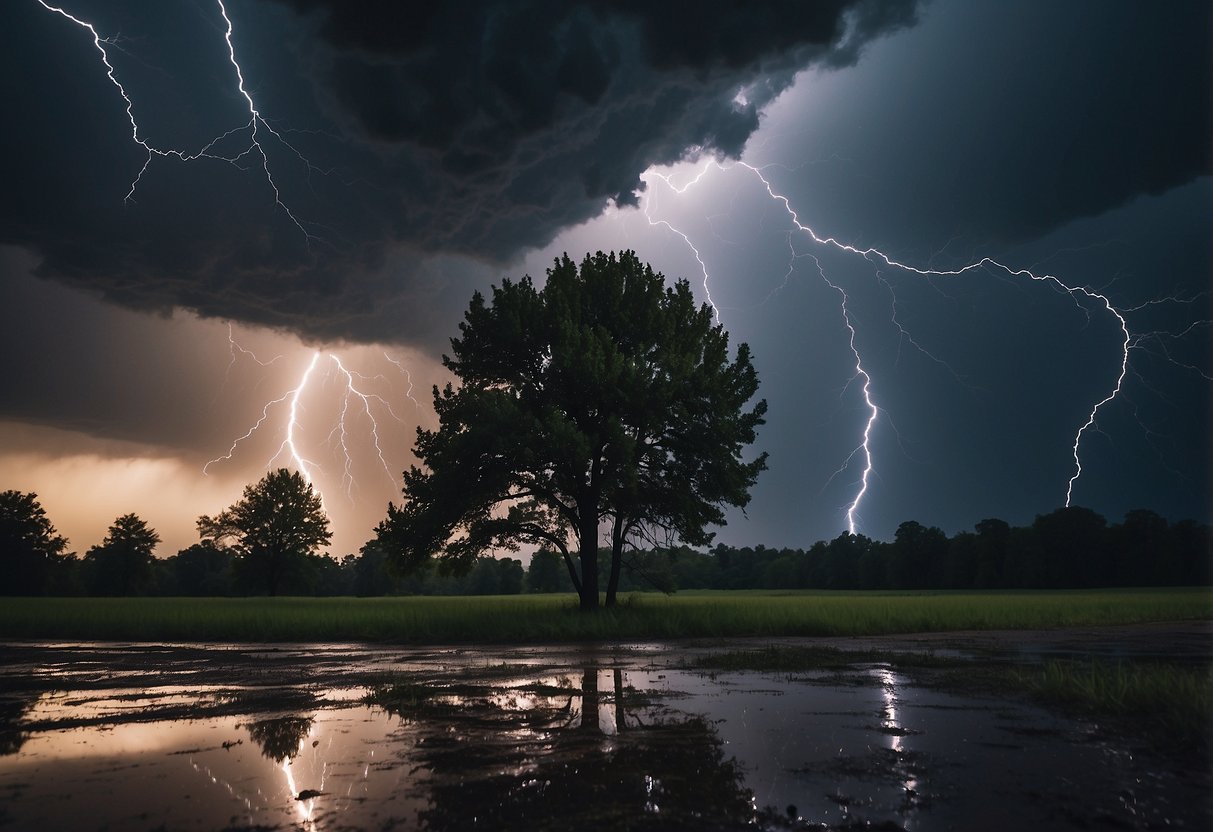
[35, 0, 319, 250]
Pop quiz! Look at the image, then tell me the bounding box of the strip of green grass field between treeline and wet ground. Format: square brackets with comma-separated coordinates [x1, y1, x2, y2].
[0, 588, 1213, 644]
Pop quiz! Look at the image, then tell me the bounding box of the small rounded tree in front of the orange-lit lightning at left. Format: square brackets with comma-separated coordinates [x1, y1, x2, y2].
[198, 468, 332, 595]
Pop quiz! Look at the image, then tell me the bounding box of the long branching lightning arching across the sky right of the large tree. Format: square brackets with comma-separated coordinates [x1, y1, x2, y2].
[640, 160, 1149, 534]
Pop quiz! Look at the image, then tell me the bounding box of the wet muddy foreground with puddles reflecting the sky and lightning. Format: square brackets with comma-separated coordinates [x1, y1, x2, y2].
[0, 622, 1213, 831]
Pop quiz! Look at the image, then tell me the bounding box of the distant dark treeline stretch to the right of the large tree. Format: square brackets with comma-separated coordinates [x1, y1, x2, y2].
[637, 507, 1213, 589]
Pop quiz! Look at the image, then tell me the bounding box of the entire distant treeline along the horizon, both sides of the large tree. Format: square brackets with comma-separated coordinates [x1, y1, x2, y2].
[0, 508, 1213, 595]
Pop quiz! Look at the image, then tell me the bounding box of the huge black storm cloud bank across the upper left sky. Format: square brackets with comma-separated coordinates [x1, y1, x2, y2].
[0, 0, 915, 349]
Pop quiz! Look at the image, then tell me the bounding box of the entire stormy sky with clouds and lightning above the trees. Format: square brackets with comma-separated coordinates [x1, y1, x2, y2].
[0, 0, 1213, 554]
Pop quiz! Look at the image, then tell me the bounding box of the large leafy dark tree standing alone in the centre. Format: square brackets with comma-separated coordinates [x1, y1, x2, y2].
[376, 251, 767, 609]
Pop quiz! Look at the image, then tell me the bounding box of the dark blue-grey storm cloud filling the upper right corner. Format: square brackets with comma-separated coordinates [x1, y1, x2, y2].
[769, 0, 1213, 256]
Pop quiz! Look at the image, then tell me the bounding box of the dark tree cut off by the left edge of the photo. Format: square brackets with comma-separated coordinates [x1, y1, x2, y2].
[0, 491, 68, 595]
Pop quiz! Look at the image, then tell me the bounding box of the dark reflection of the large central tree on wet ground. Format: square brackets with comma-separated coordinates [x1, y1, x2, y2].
[373, 665, 756, 830]
